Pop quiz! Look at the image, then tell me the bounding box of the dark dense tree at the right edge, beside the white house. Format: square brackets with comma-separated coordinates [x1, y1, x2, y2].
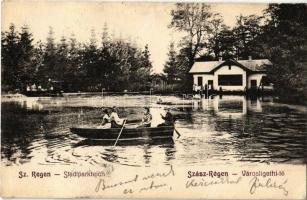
[262, 4, 307, 103]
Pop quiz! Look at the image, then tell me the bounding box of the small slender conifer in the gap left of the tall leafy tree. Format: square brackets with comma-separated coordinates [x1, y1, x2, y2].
[163, 42, 178, 84]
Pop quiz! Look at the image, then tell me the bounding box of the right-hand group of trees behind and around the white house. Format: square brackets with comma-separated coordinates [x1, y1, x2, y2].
[164, 3, 307, 102]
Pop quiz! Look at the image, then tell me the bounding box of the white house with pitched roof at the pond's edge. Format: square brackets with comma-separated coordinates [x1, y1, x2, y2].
[189, 57, 272, 91]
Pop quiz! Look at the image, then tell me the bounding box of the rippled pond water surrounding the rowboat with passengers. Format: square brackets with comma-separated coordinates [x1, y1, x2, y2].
[1, 96, 307, 167]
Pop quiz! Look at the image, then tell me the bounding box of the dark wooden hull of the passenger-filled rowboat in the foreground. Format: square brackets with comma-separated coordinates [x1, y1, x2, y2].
[70, 126, 174, 140]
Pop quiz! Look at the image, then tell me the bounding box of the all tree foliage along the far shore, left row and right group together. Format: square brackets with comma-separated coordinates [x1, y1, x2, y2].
[1, 3, 307, 102]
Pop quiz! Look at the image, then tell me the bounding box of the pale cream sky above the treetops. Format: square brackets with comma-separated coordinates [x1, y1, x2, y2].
[1, 0, 267, 73]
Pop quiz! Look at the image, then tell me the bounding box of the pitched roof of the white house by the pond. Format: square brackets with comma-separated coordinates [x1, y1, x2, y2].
[189, 59, 272, 73]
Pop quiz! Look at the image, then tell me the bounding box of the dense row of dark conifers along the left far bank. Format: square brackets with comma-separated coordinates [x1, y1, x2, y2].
[1, 24, 152, 91]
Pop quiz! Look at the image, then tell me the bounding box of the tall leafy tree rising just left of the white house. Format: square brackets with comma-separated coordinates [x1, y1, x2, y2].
[170, 3, 213, 91]
